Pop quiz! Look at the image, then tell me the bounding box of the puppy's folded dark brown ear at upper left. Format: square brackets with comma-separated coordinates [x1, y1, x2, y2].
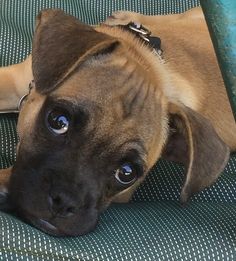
[32, 9, 118, 94]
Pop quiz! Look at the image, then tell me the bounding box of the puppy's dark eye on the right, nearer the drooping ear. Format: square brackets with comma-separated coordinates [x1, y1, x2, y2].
[115, 163, 137, 185]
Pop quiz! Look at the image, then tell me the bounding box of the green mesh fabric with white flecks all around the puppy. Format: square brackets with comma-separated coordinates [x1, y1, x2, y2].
[0, 0, 236, 261]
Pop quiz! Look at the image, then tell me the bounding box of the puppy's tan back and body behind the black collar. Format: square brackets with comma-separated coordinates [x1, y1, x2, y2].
[106, 8, 236, 150]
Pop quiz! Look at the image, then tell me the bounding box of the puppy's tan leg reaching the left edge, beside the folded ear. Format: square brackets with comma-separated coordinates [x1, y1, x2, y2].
[0, 55, 33, 112]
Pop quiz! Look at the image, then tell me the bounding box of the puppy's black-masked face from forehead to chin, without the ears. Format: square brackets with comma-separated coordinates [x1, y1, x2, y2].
[11, 57, 168, 235]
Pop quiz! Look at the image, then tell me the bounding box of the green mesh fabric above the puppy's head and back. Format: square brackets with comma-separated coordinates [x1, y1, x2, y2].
[0, 0, 199, 66]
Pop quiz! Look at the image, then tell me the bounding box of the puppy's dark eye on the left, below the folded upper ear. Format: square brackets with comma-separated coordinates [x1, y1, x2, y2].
[47, 109, 70, 135]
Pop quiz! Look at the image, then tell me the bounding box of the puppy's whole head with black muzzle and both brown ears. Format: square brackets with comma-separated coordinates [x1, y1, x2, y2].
[9, 10, 228, 235]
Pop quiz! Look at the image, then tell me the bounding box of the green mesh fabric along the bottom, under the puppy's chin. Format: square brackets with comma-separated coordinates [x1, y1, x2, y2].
[0, 201, 236, 261]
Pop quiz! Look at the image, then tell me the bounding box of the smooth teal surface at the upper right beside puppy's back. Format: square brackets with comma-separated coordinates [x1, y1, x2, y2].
[201, 0, 236, 120]
